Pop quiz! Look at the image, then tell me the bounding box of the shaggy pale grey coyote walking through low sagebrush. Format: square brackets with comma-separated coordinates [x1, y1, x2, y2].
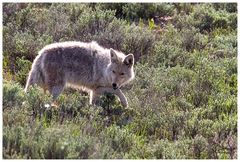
[25, 41, 134, 107]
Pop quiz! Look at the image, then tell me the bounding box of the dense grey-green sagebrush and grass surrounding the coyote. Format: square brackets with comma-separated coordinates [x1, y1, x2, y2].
[2, 3, 237, 159]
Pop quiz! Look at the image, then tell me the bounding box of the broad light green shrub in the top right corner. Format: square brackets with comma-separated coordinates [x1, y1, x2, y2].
[174, 4, 237, 33]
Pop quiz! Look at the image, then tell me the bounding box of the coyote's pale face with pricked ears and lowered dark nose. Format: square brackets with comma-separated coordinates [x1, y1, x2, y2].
[107, 49, 134, 89]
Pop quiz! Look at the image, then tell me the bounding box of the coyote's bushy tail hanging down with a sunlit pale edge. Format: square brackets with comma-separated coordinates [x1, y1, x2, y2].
[24, 56, 44, 92]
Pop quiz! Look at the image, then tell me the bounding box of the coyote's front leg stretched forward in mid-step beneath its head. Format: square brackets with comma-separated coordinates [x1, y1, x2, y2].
[95, 87, 128, 107]
